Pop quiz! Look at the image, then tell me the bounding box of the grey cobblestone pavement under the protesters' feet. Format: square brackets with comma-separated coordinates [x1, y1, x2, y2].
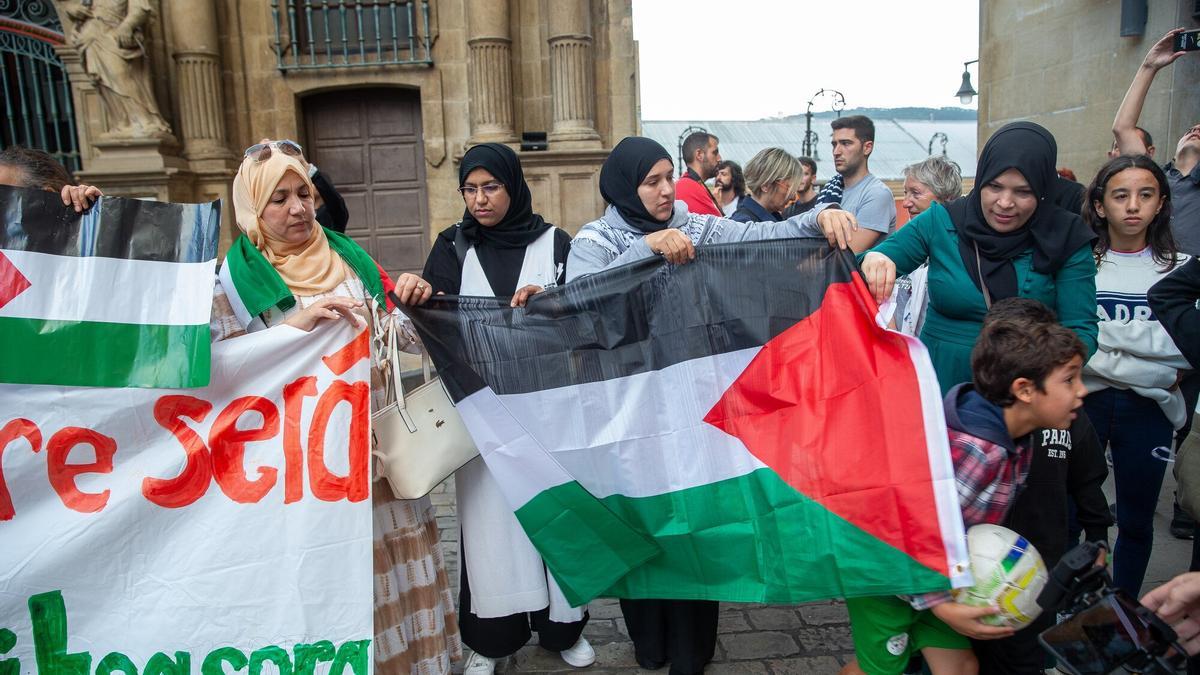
[431, 461, 1192, 675]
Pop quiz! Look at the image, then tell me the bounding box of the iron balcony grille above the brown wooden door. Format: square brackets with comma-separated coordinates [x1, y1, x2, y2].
[271, 0, 433, 73]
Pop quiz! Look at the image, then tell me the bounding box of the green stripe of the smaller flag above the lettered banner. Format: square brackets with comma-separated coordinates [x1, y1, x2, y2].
[0, 317, 211, 388]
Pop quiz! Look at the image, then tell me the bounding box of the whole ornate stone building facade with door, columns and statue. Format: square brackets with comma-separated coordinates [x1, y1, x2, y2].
[0, 0, 638, 273]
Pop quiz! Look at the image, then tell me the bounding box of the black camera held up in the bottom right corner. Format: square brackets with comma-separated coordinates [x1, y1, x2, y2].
[1038, 542, 1186, 675]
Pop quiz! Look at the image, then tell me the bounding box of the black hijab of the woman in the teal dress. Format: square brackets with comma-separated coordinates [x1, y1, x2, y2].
[947, 121, 1096, 300]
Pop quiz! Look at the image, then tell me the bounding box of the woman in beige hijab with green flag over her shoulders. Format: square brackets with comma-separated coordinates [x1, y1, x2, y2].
[210, 141, 462, 675]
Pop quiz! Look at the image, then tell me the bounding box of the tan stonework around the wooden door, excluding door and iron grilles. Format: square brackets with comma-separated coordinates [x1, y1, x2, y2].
[50, 0, 638, 257]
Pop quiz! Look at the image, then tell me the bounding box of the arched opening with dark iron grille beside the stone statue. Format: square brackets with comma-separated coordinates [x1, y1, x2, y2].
[0, 0, 79, 171]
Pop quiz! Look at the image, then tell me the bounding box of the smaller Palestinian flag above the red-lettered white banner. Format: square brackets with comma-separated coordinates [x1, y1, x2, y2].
[0, 186, 221, 388]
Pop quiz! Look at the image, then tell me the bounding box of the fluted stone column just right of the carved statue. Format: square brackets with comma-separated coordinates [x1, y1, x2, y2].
[170, 0, 233, 160]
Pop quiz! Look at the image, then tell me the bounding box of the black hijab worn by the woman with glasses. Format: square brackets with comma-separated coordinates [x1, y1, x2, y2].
[458, 143, 553, 249]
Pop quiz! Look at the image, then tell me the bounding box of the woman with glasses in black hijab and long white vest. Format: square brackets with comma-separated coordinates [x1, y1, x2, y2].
[396, 143, 585, 675]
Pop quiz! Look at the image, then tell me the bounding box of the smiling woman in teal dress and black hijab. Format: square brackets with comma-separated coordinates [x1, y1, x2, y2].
[862, 123, 1097, 394]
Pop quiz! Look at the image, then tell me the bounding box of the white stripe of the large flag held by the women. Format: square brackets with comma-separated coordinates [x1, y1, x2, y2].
[458, 347, 766, 507]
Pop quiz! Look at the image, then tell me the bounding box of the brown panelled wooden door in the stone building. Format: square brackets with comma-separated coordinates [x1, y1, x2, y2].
[302, 88, 430, 277]
